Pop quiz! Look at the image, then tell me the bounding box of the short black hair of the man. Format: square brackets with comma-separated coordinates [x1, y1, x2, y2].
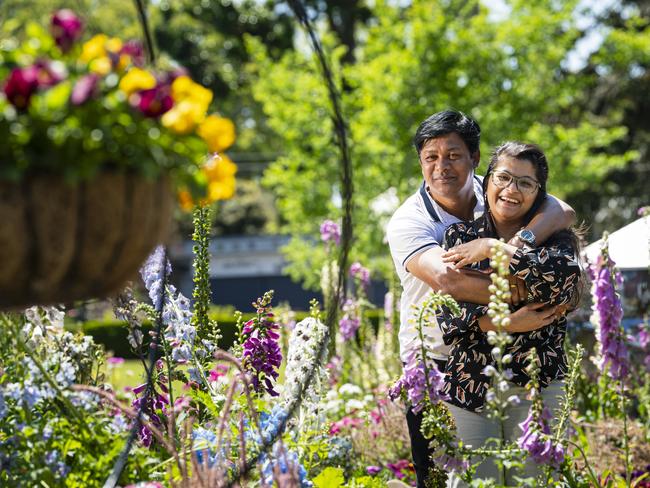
[413, 110, 481, 155]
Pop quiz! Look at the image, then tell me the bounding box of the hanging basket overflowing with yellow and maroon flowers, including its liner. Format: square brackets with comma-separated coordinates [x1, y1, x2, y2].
[0, 10, 236, 309]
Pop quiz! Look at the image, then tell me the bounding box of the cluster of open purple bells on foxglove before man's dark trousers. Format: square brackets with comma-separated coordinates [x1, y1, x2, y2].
[388, 350, 449, 413]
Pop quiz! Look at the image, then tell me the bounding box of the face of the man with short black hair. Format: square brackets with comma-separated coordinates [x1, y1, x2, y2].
[420, 132, 478, 198]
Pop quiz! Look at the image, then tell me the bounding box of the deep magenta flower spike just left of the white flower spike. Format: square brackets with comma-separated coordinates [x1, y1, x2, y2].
[242, 291, 282, 396]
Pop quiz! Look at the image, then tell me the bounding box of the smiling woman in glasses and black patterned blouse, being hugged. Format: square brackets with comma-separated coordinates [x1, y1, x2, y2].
[438, 142, 581, 482]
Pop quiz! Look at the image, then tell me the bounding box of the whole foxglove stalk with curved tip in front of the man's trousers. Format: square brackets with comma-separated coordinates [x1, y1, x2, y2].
[389, 292, 468, 487]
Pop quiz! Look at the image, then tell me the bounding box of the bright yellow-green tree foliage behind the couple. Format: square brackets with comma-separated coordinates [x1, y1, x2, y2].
[248, 0, 635, 282]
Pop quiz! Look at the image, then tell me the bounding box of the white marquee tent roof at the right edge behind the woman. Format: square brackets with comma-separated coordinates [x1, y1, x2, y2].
[583, 217, 650, 270]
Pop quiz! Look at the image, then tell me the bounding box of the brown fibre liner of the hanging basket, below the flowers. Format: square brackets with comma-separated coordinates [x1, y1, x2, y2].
[0, 172, 173, 309]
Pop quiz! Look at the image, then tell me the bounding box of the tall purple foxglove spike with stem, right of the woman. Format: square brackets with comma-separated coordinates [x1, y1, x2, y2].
[589, 233, 631, 485]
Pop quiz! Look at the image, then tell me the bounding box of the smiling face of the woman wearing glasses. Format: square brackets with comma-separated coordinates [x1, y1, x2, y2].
[487, 156, 539, 224]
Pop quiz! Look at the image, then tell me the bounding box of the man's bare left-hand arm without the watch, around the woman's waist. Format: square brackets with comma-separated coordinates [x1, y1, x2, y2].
[406, 246, 491, 304]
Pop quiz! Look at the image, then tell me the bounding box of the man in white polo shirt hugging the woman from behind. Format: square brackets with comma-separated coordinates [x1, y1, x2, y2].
[386, 110, 575, 487]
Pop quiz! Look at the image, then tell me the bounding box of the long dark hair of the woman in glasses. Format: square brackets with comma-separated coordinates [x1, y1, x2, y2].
[483, 141, 585, 309]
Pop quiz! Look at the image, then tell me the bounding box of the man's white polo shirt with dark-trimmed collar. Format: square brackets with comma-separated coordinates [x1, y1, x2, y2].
[386, 176, 484, 362]
